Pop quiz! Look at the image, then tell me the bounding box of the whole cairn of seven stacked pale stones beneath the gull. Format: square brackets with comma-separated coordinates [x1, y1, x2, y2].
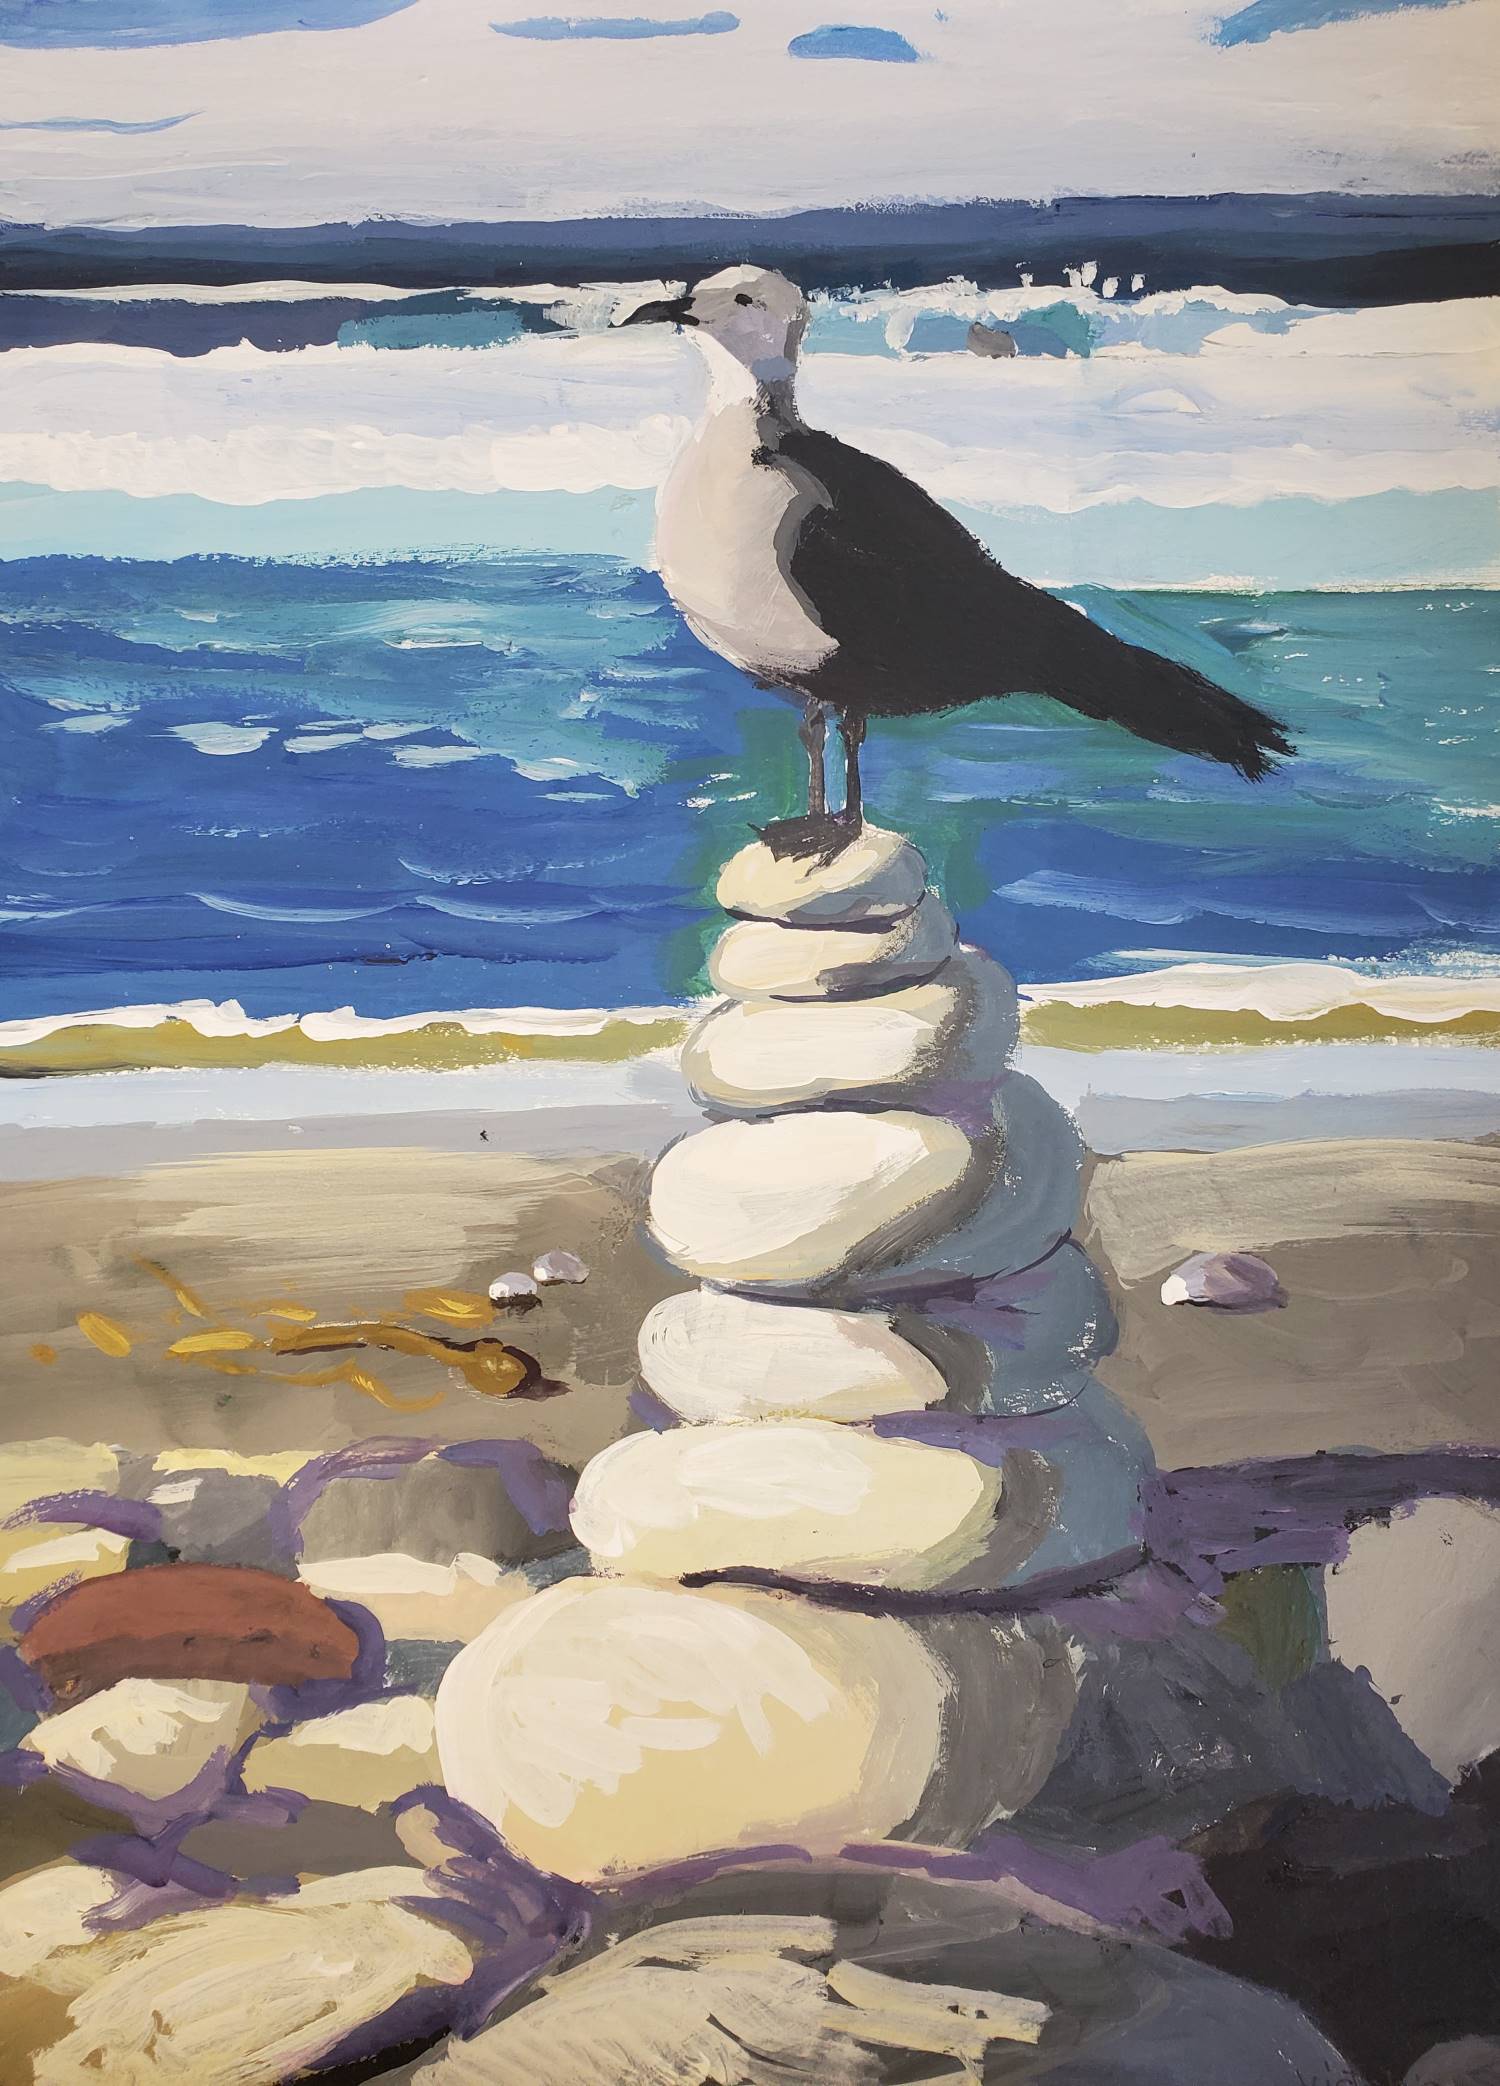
[436, 826, 1150, 1882]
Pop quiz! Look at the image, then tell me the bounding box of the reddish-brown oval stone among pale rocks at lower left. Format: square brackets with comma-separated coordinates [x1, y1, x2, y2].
[21, 1565, 359, 1702]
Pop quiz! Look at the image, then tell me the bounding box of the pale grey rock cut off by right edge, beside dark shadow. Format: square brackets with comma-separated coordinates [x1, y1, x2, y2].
[1323, 1500, 1500, 1781]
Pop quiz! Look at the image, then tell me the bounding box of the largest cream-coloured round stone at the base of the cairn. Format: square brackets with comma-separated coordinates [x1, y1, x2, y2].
[438, 1579, 947, 1882]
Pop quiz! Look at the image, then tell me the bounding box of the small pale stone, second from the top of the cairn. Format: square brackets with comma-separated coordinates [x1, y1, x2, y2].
[709, 891, 958, 999]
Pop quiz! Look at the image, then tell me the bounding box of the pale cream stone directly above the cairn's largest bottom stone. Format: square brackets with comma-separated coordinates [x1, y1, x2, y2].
[574, 1421, 1001, 1592]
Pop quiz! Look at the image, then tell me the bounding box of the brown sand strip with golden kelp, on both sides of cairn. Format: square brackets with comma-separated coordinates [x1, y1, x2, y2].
[0, 1122, 1500, 1466]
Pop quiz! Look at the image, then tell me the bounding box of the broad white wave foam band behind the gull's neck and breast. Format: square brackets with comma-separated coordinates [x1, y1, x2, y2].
[0, 306, 1500, 515]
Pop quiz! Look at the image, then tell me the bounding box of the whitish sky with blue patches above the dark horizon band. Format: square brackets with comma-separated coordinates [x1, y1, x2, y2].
[0, 0, 1500, 225]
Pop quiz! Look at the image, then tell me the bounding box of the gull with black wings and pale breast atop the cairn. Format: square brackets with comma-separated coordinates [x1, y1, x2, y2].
[615, 267, 1293, 855]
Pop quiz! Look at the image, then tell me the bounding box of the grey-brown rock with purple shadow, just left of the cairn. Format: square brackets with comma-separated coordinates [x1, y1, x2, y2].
[300, 1452, 572, 1565]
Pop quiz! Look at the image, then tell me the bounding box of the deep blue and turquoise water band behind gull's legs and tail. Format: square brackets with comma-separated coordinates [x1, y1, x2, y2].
[0, 555, 1500, 1018]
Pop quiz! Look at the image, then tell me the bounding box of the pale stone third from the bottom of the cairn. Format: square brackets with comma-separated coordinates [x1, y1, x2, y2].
[638, 1289, 947, 1421]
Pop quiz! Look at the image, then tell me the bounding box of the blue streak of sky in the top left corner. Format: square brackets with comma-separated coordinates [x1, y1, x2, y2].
[0, 0, 413, 50]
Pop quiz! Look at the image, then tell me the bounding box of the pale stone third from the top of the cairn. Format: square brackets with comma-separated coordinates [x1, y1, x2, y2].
[682, 949, 1018, 1114]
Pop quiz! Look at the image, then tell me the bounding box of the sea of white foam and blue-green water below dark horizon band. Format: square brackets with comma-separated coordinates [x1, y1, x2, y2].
[0, 228, 1500, 1059]
